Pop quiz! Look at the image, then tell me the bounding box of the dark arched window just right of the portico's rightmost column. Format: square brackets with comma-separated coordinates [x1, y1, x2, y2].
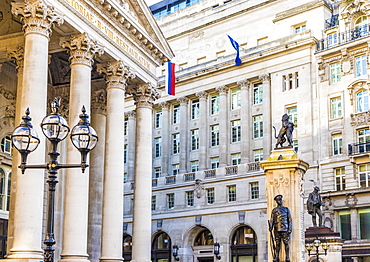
[152, 232, 171, 262]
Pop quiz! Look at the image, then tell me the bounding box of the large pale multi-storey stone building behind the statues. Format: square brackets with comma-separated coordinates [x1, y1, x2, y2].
[120, 0, 370, 262]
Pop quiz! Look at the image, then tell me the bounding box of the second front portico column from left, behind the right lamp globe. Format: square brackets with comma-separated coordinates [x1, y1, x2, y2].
[60, 33, 103, 262]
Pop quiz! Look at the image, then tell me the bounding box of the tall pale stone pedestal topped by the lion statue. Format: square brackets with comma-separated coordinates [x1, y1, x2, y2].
[260, 147, 310, 262]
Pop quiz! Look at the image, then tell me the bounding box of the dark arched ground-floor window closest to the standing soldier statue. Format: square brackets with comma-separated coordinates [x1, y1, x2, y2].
[230, 226, 258, 262]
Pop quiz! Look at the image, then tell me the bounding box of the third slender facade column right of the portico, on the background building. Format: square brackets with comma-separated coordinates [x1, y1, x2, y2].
[196, 91, 208, 170]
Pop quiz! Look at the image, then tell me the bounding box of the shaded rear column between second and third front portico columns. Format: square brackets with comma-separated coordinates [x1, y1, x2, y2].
[87, 89, 107, 262]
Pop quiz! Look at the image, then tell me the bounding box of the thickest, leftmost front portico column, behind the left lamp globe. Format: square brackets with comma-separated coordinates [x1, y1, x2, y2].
[8, 1, 63, 261]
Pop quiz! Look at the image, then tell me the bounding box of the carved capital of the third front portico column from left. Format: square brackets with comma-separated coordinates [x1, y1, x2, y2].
[96, 60, 136, 90]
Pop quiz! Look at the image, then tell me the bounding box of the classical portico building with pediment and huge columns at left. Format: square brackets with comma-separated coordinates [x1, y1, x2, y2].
[0, 0, 173, 261]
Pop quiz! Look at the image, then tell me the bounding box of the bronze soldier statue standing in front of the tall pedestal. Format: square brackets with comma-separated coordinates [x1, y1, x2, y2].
[269, 195, 292, 262]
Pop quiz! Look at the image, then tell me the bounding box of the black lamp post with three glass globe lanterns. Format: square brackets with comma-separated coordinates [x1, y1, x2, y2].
[12, 98, 98, 262]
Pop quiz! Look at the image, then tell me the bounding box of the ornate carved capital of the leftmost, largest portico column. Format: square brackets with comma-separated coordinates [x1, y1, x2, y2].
[11, 0, 64, 38]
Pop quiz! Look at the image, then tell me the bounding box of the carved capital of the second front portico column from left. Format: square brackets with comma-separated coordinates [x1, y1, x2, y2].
[59, 33, 104, 67]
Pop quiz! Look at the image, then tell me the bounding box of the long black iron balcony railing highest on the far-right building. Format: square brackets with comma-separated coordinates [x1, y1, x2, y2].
[316, 24, 370, 52]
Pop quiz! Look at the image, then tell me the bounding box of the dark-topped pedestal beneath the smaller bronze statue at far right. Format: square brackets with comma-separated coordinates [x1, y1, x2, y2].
[305, 227, 343, 262]
